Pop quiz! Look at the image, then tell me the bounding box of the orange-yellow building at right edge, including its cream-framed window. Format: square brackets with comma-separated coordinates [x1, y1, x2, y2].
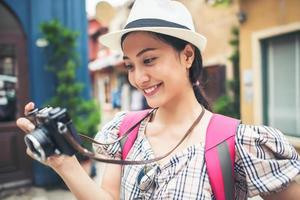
[239, 0, 300, 148]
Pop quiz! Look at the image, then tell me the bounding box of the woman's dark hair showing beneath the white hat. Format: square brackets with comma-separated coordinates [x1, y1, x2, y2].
[121, 32, 211, 110]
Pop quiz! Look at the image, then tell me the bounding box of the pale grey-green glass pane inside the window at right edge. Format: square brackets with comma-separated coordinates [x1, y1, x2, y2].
[267, 34, 300, 136]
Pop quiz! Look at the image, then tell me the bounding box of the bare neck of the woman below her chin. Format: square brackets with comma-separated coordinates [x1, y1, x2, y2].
[155, 88, 202, 125]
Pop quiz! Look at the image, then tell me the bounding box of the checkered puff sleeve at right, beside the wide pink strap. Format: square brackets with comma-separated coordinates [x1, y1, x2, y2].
[235, 124, 300, 197]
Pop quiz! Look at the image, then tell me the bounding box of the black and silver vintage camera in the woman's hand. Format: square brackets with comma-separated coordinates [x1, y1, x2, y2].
[24, 107, 81, 160]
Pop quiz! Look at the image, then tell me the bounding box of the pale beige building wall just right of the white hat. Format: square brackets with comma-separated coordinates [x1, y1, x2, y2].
[180, 0, 239, 79]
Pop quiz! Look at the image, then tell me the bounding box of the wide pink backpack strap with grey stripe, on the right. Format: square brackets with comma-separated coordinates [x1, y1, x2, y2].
[205, 114, 240, 200]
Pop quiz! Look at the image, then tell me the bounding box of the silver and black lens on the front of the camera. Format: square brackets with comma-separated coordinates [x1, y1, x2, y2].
[24, 128, 55, 160]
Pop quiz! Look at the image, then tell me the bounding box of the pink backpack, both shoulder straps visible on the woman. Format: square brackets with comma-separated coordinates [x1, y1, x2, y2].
[119, 110, 240, 200]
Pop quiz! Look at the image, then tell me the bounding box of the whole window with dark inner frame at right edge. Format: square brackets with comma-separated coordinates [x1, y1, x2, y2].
[262, 32, 300, 137]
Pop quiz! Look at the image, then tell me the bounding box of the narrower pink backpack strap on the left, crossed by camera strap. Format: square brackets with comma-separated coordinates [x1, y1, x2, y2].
[119, 109, 149, 160]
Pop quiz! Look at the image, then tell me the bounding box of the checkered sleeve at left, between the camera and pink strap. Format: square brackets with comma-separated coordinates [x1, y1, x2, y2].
[93, 112, 126, 159]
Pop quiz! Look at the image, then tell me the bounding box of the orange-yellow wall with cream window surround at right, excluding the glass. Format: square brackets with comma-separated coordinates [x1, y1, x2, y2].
[239, 0, 300, 123]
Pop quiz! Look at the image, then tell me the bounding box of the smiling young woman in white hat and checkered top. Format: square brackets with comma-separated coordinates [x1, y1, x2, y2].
[17, 0, 300, 200]
